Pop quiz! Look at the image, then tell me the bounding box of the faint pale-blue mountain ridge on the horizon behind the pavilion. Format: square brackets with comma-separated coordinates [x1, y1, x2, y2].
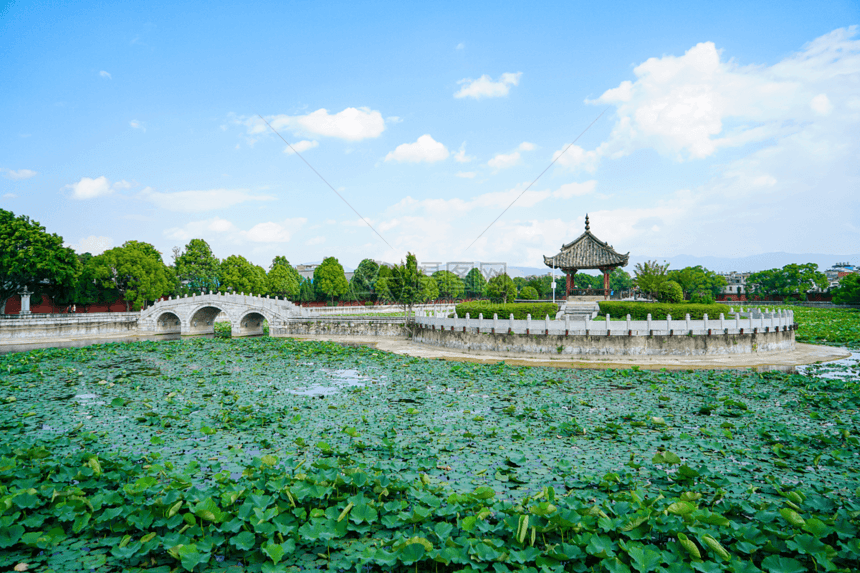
[508, 253, 860, 277]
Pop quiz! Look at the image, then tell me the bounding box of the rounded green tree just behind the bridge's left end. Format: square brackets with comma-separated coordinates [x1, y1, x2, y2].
[87, 241, 176, 312]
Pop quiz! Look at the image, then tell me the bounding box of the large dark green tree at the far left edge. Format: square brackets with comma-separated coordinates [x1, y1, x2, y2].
[0, 209, 81, 314]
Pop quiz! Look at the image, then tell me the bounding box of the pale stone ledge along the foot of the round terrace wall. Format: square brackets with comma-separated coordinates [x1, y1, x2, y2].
[292, 336, 851, 371]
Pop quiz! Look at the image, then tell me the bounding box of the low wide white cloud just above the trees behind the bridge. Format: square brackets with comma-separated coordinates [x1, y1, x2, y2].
[164, 217, 307, 241]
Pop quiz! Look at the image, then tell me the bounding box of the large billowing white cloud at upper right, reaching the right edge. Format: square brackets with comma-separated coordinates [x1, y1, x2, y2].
[556, 26, 860, 169]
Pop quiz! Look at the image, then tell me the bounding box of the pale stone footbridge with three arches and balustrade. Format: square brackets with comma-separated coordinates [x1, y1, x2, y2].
[137, 293, 303, 336]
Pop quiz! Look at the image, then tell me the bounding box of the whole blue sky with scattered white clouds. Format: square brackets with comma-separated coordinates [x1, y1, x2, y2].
[0, 1, 860, 267]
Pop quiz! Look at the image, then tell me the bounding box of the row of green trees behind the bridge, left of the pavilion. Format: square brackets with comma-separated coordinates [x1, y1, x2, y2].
[0, 209, 517, 314]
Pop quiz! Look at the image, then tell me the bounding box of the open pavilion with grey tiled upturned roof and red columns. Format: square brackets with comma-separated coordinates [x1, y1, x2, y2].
[543, 215, 630, 299]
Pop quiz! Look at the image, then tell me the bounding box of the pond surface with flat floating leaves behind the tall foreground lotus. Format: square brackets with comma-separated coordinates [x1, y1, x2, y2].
[0, 338, 860, 500]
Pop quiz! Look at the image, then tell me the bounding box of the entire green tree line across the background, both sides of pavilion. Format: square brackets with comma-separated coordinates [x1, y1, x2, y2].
[0, 209, 860, 314]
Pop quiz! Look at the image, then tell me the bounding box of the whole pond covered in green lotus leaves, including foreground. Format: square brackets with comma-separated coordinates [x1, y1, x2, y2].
[0, 337, 860, 573]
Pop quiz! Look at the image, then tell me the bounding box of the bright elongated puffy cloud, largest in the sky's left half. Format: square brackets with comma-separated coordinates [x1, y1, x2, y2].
[249, 107, 385, 141]
